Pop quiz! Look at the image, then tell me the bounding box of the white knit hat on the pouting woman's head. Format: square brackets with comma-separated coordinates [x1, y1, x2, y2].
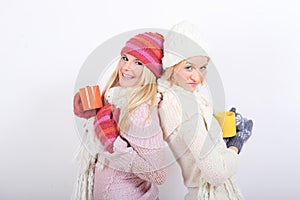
[162, 21, 208, 70]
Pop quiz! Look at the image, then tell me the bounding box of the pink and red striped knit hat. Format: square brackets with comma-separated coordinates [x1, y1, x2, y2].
[121, 32, 164, 78]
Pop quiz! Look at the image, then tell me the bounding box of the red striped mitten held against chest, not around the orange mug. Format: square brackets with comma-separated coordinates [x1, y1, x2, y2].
[94, 104, 119, 153]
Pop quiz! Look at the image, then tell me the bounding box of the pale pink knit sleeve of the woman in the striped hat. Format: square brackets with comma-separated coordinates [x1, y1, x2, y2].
[105, 104, 166, 184]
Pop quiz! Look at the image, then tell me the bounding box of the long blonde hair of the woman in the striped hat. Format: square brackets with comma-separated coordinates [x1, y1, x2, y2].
[102, 65, 157, 132]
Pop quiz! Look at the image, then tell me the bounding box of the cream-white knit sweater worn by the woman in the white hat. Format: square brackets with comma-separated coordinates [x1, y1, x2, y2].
[158, 80, 243, 200]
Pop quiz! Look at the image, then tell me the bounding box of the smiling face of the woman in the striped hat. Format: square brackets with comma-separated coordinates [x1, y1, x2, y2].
[118, 54, 145, 87]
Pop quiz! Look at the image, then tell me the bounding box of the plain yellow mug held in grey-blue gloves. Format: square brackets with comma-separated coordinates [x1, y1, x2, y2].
[215, 111, 236, 138]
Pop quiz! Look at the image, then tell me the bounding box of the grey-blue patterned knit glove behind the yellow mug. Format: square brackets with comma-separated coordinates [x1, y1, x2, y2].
[225, 108, 253, 153]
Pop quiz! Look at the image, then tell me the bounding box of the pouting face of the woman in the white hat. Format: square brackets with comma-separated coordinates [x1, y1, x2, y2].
[173, 56, 209, 92]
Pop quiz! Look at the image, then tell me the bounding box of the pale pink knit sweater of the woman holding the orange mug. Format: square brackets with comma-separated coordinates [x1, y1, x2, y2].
[94, 88, 166, 200]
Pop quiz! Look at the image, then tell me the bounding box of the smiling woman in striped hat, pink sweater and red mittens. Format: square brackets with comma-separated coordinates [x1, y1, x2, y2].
[74, 32, 166, 200]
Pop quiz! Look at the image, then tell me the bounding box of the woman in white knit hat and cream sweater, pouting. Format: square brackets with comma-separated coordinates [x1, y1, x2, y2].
[158, 22, 253, 200]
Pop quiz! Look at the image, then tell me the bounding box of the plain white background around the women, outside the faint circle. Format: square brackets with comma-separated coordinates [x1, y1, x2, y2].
[0, 0, 300, 200]
